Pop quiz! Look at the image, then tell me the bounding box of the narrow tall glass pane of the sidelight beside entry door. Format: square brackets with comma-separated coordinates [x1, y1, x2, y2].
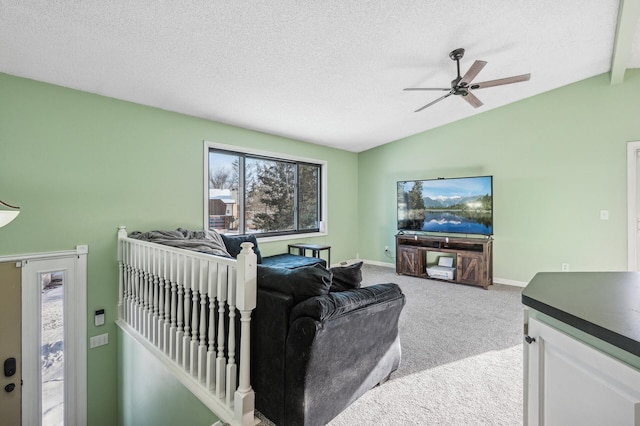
[40, 272, 64, 426]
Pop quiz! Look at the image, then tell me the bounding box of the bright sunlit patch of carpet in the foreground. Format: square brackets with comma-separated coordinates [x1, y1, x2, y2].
[330, 346, 522, 426]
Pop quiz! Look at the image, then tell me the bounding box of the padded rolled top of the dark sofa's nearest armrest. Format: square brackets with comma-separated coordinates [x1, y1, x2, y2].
[289, 283, 403, 323]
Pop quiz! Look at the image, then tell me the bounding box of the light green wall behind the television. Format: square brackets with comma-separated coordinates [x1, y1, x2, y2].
[358, 71, 640, 282]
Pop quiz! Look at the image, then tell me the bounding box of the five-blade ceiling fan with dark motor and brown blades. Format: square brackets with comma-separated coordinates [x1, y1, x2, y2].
[404, 49, 531, 112]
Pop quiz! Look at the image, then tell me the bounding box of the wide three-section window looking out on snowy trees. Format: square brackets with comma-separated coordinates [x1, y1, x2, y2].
[205, 144, 326, 236]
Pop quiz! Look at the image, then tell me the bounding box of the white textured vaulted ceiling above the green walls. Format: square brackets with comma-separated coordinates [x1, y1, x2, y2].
[0, 0, 640, 152]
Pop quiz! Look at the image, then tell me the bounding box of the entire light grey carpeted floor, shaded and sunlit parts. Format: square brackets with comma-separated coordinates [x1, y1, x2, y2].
[261, 265, 523, 426]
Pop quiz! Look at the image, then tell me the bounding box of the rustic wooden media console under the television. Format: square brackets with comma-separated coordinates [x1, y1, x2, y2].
[396, 234, 493, 290]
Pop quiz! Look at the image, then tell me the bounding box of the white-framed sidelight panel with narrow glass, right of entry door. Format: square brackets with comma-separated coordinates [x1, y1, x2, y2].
[22, 255, 86, 426]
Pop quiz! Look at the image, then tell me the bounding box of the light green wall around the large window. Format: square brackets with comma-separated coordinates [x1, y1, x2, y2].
[0, 74, 358, 426]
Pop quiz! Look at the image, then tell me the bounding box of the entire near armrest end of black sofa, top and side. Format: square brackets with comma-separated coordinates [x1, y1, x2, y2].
[278, 284, 405, 426]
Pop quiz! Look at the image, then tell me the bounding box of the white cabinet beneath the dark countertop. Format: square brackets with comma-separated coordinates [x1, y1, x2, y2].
[524, 318, 640, 426]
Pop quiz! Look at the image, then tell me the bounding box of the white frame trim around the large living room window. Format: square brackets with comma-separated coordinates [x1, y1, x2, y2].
[202, 141, 329, 241]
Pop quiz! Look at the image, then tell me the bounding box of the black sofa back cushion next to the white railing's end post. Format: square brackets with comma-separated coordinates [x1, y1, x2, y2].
[258, 264, 331, 303]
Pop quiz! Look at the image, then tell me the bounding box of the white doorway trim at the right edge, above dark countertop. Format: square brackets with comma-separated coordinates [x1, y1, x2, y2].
[627, 141, 640, 271]
